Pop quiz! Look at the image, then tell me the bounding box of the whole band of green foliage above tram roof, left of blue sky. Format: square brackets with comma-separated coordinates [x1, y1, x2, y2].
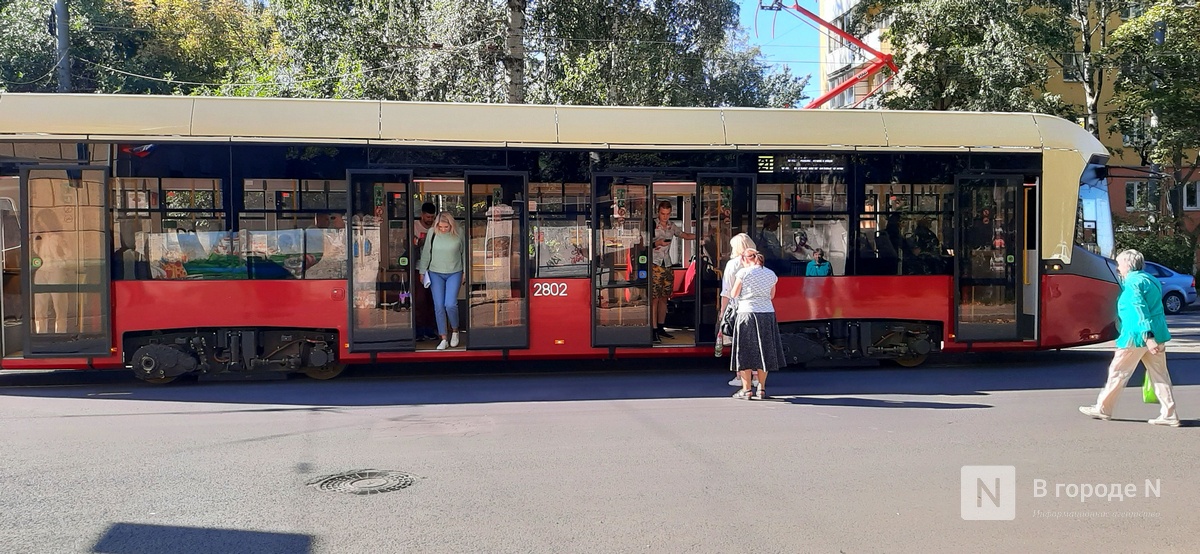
[7, 0, 808, 107]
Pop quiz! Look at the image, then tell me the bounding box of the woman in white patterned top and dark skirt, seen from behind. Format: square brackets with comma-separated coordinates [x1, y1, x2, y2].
[730, 249, 787, 399]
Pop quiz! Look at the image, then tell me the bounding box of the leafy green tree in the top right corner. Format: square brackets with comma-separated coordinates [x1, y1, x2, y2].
[1108, 0, 1200, 218]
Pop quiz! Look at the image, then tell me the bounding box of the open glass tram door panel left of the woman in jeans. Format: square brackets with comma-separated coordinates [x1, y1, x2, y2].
[346, 171, 420, 353]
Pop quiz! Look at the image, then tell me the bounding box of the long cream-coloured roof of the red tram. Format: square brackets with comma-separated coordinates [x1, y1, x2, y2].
[0, 94, 1108, 159]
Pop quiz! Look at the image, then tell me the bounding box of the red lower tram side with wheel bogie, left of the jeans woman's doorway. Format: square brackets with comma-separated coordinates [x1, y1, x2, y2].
[113, 279, 359, 377]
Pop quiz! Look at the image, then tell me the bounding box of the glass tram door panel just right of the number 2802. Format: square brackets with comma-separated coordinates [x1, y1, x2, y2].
[592, 175, 653, 347]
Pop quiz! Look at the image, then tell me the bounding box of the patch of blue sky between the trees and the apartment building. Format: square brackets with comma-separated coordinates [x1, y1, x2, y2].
[738, 0, 821, 98]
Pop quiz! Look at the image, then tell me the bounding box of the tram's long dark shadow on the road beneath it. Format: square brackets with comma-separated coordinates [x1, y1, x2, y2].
[0, 350, 1200, 410]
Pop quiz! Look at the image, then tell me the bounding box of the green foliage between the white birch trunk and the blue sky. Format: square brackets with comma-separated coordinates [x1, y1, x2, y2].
[528, 0, 808, 107]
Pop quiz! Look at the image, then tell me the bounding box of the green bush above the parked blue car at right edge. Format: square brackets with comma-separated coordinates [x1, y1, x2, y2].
[1115, 211, 1196, 275]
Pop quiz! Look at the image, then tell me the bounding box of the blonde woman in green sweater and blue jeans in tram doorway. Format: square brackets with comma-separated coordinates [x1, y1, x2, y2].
[416, 211, 467, 350]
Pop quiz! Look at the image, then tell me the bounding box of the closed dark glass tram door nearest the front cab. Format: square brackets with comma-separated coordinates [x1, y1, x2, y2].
[954, 175, 1026, 342]
